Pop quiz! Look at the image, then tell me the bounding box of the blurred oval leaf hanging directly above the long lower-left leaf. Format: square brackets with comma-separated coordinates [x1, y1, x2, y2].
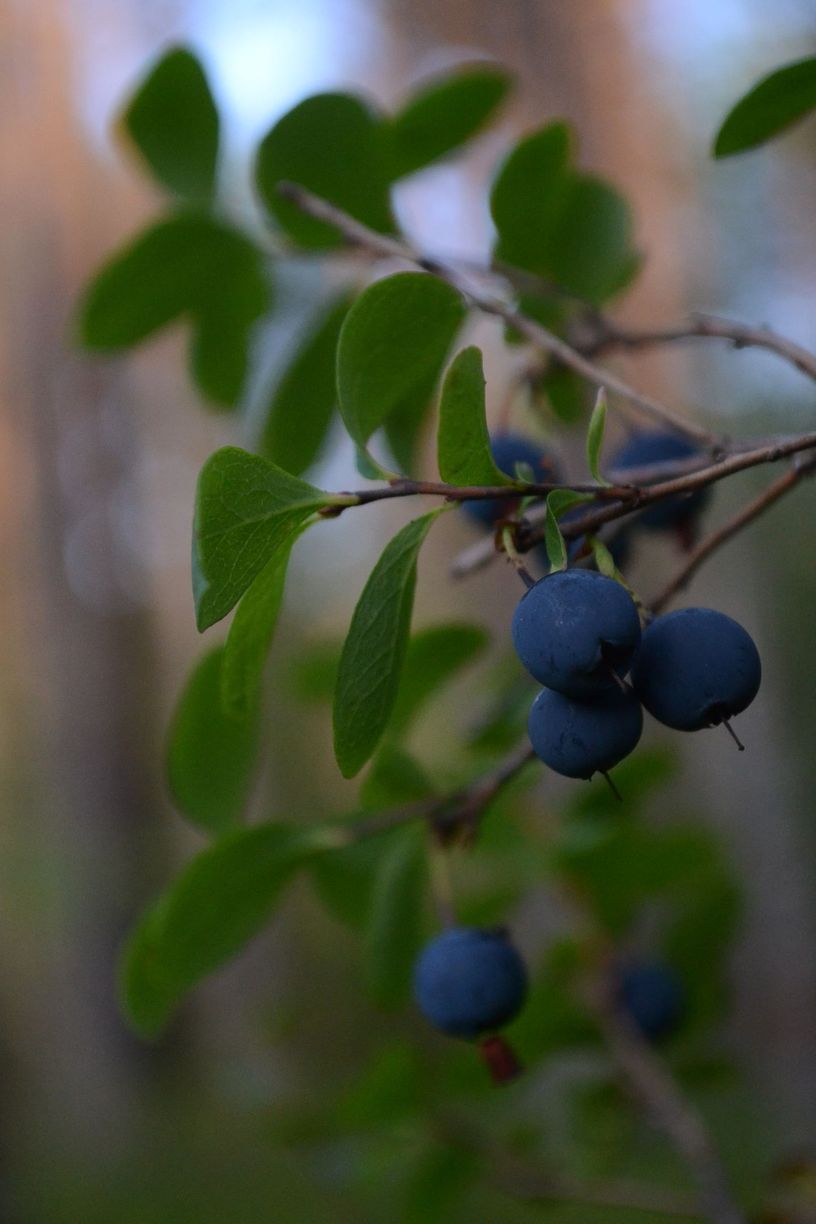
[166, 645, 258, 834]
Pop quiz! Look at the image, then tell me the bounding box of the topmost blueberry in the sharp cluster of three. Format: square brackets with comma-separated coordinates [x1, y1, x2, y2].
[513, 569, 640, 699]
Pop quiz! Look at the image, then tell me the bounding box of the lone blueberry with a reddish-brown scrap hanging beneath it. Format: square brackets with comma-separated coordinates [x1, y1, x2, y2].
[414, 927, 527, 1038]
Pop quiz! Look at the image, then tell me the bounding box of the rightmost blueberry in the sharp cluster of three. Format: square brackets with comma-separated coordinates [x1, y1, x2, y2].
[632, 608, 762, 731]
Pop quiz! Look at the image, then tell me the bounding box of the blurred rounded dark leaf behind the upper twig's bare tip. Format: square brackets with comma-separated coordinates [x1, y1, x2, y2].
[256, 93, 394, 250]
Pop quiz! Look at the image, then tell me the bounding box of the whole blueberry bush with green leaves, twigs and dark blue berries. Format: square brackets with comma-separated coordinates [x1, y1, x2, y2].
[78, 49, 816, 1224]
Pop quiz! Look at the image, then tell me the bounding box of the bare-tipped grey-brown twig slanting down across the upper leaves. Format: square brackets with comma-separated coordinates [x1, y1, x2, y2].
[278, 182, 722, 448]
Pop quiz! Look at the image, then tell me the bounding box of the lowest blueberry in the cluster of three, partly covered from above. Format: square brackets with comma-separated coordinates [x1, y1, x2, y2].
[527, 688, 644, 778]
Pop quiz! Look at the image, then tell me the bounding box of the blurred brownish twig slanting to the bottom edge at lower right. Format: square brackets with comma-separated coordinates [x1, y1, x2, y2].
[588, 987, 745, 1224]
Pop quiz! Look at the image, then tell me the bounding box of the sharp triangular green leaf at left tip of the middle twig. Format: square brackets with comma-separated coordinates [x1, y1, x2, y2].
[193, 447, 329, 632]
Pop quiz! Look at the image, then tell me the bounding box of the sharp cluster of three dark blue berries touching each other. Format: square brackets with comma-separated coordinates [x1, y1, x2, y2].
[513, 569, 761, 778]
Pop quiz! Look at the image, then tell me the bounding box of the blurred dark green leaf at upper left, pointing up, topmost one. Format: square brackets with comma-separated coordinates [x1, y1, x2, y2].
[120, 47, 219, 202]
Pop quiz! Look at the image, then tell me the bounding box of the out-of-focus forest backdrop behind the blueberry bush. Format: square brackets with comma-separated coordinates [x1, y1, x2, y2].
[0, 0, 816, 1224]
